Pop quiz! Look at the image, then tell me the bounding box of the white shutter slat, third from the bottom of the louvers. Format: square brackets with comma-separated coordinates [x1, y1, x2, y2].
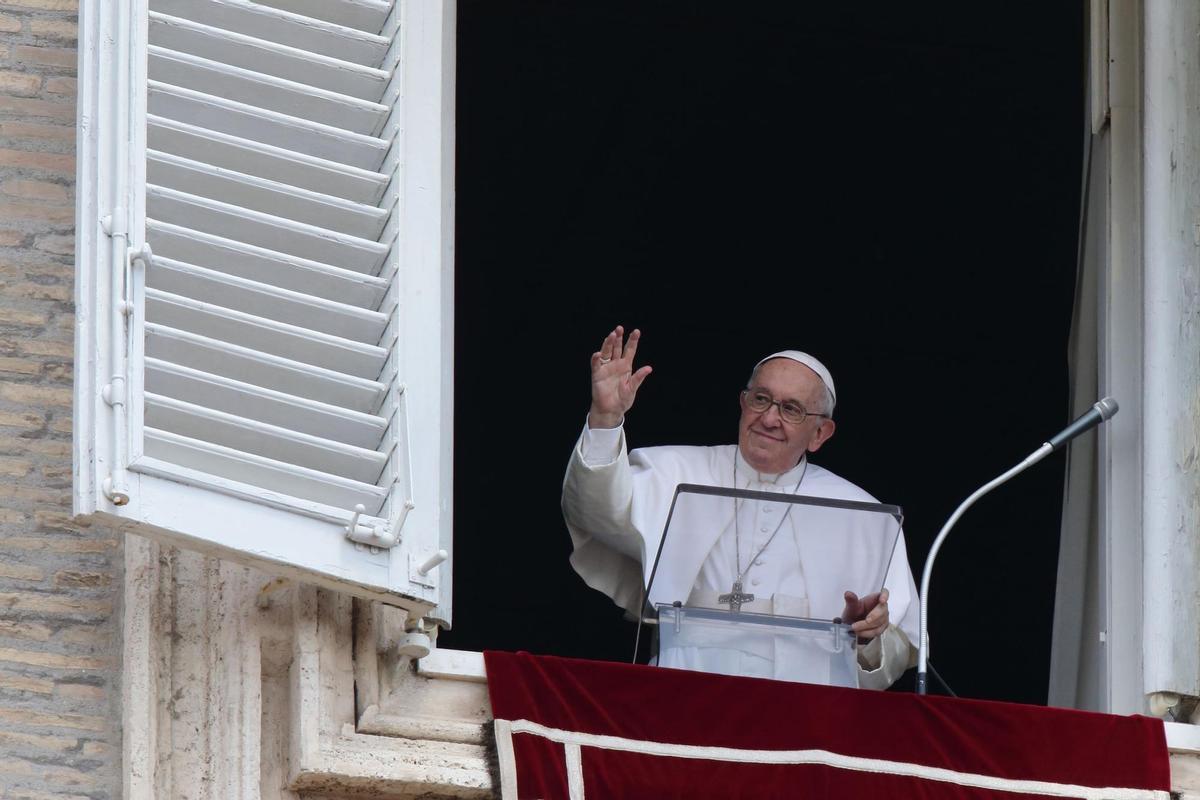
[145, 357, 388, 449]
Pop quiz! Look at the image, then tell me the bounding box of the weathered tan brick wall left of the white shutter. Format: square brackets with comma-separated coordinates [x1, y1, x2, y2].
[0, 0, 121, 800]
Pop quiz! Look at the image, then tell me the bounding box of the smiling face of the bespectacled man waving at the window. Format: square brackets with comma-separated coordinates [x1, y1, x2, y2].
[738, 359, 834, 474]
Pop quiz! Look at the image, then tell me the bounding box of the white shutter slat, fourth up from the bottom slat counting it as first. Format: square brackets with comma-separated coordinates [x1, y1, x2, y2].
[145, 323, 386, 414]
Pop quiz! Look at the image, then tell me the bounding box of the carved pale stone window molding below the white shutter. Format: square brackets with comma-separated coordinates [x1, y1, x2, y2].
[122, 535, 492, 800]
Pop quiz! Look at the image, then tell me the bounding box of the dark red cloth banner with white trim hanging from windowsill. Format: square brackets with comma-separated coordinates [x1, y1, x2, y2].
[485, 652, 1170, 800]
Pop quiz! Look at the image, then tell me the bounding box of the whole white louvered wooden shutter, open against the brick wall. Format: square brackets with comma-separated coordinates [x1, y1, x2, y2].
[76, 0, 455, 619]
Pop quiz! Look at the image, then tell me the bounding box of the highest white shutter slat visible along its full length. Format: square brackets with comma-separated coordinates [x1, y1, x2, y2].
[149, 11, 390, 102]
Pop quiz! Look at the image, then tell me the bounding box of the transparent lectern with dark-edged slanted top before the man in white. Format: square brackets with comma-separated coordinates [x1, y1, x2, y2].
[643, 483, 904, 686]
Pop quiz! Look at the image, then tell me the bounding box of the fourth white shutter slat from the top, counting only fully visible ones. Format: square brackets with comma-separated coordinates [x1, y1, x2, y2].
[146, 114, 389, 205]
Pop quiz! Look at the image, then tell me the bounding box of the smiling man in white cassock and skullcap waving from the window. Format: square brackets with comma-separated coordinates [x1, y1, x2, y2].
[563, 326, 918, 688]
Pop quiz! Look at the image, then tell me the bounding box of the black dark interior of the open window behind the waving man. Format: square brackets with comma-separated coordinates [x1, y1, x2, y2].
[442, 0, 1084, 703]
